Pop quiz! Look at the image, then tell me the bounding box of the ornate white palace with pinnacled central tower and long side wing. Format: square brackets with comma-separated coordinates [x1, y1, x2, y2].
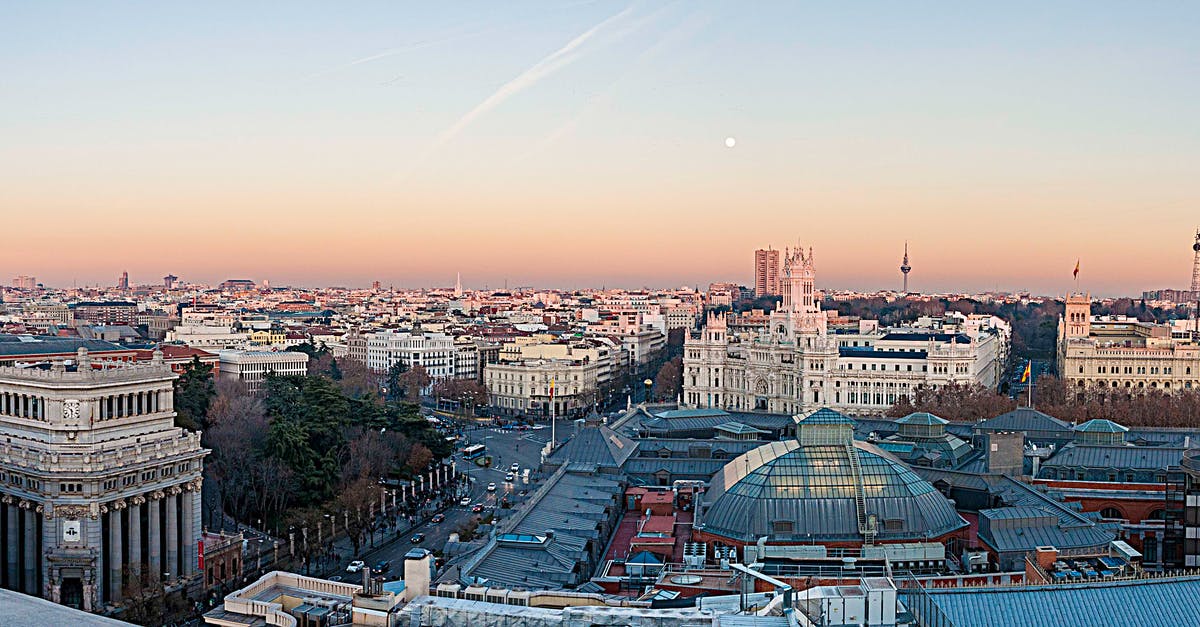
[683, 249, 1007, 416]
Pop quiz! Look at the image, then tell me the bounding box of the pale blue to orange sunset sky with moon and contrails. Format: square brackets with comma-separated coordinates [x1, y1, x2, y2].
[0, 0, 1200, 295]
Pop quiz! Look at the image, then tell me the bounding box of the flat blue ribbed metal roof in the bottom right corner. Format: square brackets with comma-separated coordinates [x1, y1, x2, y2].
[902, 577, 1200, 627]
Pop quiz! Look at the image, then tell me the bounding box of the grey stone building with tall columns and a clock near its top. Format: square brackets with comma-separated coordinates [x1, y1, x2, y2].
[0, 348, 208, 611]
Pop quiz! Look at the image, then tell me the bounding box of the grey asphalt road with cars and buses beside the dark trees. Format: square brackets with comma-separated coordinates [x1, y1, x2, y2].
[330, 420, 552, 580]
